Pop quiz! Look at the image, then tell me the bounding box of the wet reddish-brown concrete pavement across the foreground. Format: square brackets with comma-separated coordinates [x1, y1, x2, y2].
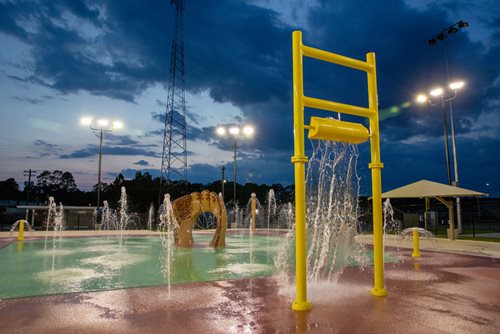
[0, 250, 500, 333]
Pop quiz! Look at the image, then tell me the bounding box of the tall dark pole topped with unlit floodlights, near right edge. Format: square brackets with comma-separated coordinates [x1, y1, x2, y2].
[427, 20, 469, 232]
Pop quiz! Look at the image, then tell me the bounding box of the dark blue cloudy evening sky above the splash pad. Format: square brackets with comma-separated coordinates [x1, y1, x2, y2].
[0, 0, 500, 196]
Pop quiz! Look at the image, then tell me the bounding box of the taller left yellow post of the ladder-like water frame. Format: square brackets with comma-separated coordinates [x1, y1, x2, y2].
[292, 31, 311, 311]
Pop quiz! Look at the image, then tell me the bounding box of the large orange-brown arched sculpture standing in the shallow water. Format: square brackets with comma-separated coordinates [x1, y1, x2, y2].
[172, 190, 227, 247]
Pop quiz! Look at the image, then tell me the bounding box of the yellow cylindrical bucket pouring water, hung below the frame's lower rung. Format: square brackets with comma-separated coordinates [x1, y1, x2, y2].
[307, 117, 370, 144]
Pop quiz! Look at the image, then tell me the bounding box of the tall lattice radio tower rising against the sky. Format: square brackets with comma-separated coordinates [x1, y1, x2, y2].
[159, 0, 187, 204]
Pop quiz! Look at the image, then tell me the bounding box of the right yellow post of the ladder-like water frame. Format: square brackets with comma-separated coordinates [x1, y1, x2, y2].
[366, 52, 387, 297]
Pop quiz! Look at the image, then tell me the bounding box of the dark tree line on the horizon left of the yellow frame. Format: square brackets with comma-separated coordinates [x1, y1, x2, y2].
[0, 170, 294, 212]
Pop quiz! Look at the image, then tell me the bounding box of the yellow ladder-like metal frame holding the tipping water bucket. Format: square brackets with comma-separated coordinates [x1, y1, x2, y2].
[292, 31, 387, 311]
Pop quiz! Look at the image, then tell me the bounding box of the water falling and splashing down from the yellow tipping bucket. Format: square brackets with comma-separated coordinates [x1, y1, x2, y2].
[275, 141, 368, 287]
